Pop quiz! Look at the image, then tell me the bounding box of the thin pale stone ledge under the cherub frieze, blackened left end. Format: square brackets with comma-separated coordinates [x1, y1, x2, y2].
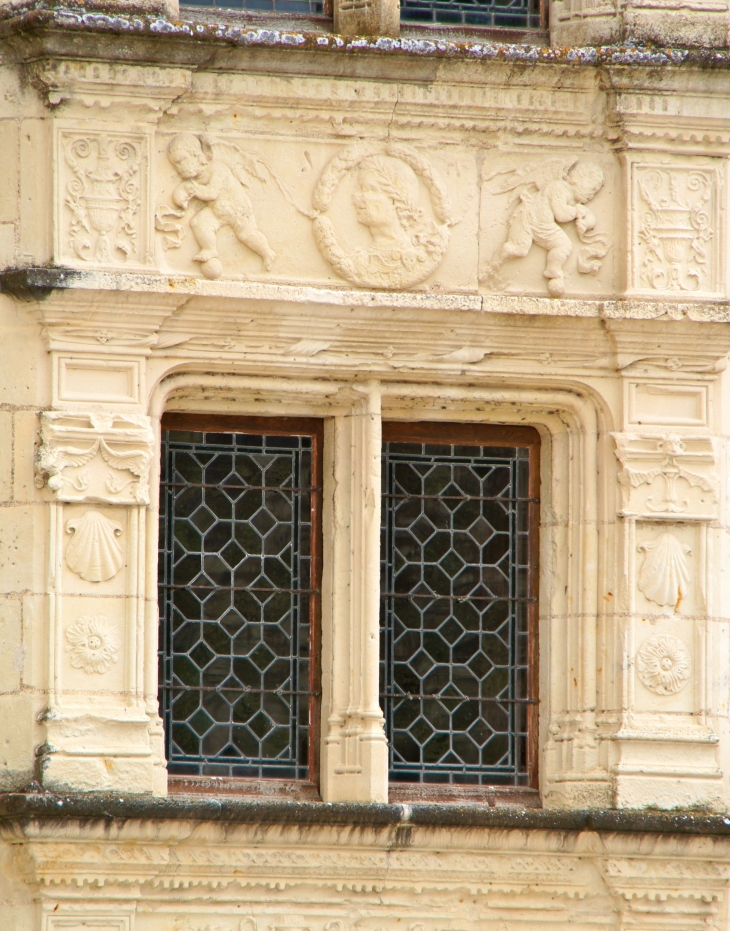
[0, 267, 730, 323]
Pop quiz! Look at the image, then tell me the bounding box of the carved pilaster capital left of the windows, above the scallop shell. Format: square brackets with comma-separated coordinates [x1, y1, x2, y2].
[35, 412, 154, 506]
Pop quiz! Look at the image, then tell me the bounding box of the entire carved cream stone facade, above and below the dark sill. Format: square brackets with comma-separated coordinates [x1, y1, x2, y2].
[0, 0, 730, 931]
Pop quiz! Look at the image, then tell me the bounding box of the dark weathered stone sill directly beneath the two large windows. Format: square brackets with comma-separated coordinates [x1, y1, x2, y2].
[0, 792, 730, 837]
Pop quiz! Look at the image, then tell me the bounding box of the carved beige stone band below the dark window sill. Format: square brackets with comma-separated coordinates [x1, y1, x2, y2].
[3, 820, 728, 931]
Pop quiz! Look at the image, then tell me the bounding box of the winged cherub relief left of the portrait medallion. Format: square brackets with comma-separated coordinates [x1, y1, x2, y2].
[157, 133, 276, 278]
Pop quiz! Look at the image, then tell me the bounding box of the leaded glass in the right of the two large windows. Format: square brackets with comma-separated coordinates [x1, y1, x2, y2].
[380, 442, 533, 786]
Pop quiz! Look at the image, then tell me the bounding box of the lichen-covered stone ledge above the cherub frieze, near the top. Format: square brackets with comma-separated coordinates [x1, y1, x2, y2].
[0, 2, 730, 68]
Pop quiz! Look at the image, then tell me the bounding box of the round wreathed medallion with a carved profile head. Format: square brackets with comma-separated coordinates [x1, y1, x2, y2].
[313, 143, 458, 288]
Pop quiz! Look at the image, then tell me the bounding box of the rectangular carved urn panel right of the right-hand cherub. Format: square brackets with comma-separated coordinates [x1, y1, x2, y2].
[634, 165, 717, 291]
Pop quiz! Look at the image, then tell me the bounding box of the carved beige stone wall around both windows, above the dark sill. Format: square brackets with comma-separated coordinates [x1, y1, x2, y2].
[0, 0, 730, 832]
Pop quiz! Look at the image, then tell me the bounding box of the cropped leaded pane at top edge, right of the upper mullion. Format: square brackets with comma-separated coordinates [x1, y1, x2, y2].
[400, 0, 541, 29]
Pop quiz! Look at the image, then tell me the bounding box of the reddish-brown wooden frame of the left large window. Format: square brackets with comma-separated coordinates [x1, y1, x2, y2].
[158, 411, 324, 801]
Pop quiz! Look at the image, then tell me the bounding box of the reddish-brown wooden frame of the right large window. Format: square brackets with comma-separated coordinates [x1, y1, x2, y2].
[381, 418, 541, 807]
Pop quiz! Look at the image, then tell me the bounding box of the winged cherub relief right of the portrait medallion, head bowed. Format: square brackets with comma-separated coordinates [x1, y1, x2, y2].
[481, 159, 608, 297]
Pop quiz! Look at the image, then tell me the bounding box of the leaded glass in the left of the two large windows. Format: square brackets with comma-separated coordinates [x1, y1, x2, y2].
[159, 430, 313, 779]
